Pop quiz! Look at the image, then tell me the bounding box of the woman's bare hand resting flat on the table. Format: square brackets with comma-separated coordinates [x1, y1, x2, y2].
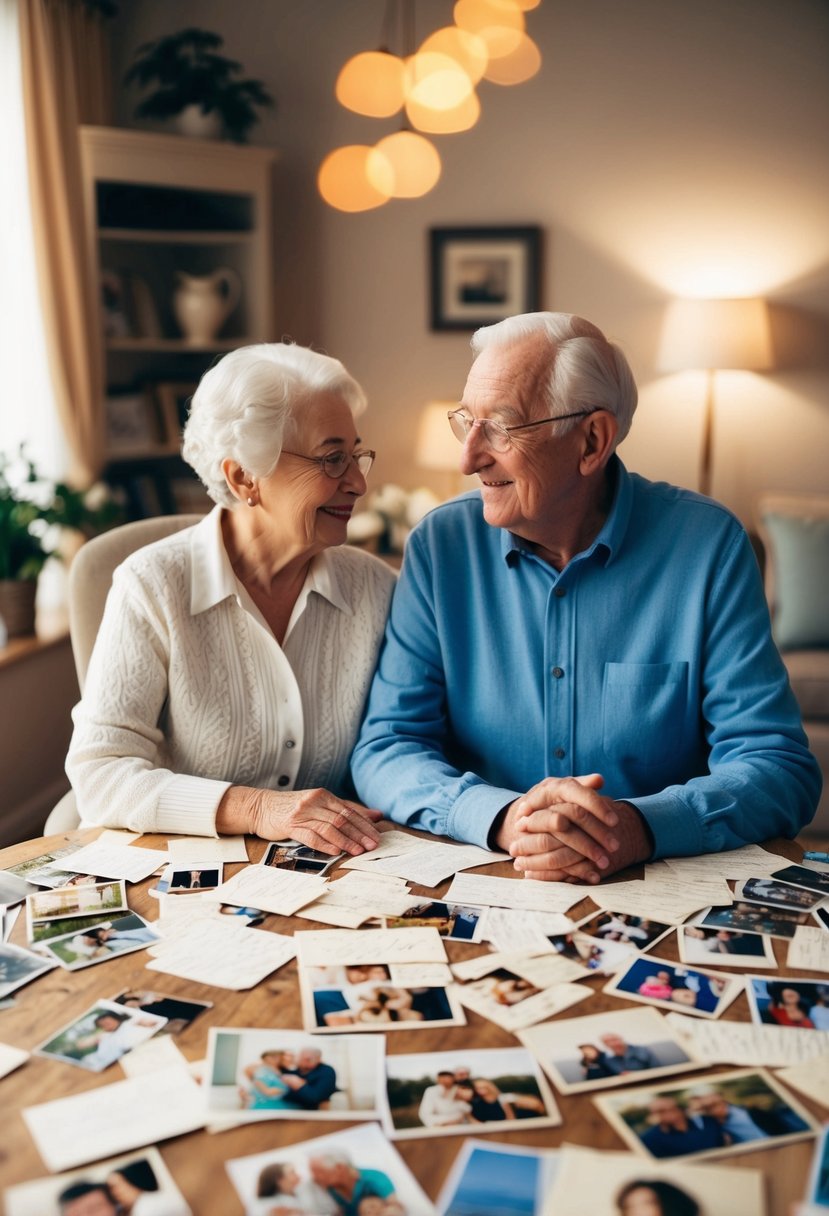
[216, 786, 383, 856]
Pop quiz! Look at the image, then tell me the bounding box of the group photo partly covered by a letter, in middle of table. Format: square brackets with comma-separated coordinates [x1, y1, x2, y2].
[299, 963, 466, 1034]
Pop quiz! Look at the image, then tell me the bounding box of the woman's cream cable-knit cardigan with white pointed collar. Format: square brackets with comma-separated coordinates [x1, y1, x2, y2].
[67, 508, 394, 835]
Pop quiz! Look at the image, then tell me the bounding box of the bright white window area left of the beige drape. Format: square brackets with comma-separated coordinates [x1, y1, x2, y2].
[0, 0, 69, 478]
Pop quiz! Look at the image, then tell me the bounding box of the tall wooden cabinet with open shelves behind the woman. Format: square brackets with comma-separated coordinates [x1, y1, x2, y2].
[80, 126, 276, 518]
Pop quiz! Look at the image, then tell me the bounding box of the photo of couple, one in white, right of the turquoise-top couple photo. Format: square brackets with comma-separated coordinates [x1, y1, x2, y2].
[384, 1047, 562, 1139]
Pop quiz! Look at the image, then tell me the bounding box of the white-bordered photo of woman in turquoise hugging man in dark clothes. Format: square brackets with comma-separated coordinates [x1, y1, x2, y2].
[204, 1028, 385, 1122]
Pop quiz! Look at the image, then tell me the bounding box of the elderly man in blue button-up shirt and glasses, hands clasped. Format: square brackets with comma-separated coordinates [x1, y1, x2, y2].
[353, 313, 820, 882]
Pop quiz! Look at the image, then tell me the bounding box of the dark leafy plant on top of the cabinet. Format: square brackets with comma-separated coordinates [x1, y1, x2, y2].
[124, 29, 275, 143]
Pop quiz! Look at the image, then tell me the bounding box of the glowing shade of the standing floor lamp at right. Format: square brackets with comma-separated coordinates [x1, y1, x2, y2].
[659, 299, 774, 372]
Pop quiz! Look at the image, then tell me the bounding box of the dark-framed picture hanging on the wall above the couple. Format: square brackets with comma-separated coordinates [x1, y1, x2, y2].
[429, 225, 541, 331]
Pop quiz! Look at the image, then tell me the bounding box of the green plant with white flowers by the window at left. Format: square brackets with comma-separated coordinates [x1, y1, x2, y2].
[0, 451, 123, 637]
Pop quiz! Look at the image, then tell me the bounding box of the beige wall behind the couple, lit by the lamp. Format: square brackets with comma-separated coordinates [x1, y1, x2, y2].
[113, 0, 829, 518]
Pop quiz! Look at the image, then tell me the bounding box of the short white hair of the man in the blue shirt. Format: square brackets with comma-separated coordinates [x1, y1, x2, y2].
[472, 313, 638, 446]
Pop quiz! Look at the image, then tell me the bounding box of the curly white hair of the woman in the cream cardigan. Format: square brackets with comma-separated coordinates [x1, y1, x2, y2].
[181, 342, 366, 507]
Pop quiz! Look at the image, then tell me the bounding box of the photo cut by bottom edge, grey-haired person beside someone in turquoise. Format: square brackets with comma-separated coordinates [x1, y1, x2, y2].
[225, 1124, 435, 1216]
